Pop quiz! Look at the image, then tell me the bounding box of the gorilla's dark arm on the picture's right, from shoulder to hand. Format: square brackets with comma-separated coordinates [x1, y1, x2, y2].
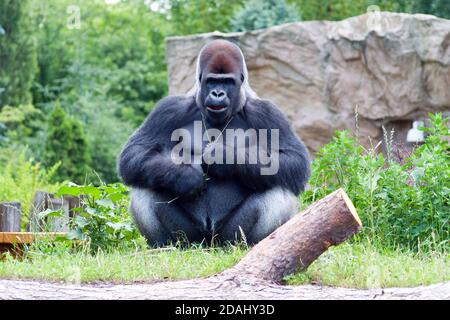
[215, 99, 310, 195]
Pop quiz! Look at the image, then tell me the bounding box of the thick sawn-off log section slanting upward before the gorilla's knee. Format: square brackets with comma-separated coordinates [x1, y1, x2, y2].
[230, 189, 362, 282]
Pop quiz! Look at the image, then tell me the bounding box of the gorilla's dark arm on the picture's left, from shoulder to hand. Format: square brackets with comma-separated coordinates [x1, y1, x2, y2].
[118, 97, 204, 195]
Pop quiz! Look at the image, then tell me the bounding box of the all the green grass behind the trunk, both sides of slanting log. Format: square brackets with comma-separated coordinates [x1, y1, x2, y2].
[0, 243, 450, 288]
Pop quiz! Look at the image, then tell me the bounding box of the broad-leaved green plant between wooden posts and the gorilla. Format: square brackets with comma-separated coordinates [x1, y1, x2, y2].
[58, 183, 140, 252]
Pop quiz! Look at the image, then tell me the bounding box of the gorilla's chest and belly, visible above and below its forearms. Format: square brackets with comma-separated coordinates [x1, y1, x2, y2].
[175, 119, 256, 230]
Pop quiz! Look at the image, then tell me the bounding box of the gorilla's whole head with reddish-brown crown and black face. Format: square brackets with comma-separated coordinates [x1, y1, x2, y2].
[197, 40, 245, 124]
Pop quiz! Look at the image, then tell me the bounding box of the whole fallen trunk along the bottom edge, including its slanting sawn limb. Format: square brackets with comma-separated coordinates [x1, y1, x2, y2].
[0, 189, 442, 300]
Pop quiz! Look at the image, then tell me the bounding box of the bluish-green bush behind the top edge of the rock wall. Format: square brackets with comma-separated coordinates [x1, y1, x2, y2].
[231, 0, 300, 31]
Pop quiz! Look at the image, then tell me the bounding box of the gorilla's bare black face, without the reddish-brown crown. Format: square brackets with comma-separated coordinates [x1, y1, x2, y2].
[200, 73, 242, 124]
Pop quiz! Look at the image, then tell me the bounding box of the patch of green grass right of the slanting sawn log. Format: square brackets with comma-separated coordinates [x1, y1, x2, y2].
[286, 243, 450, 288]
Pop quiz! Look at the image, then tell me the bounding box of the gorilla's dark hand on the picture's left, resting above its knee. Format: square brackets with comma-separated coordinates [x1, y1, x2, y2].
[172, 164, 205, 200]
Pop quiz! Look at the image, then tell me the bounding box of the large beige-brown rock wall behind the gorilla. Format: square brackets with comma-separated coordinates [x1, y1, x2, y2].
[166, 12, 450, 152]
